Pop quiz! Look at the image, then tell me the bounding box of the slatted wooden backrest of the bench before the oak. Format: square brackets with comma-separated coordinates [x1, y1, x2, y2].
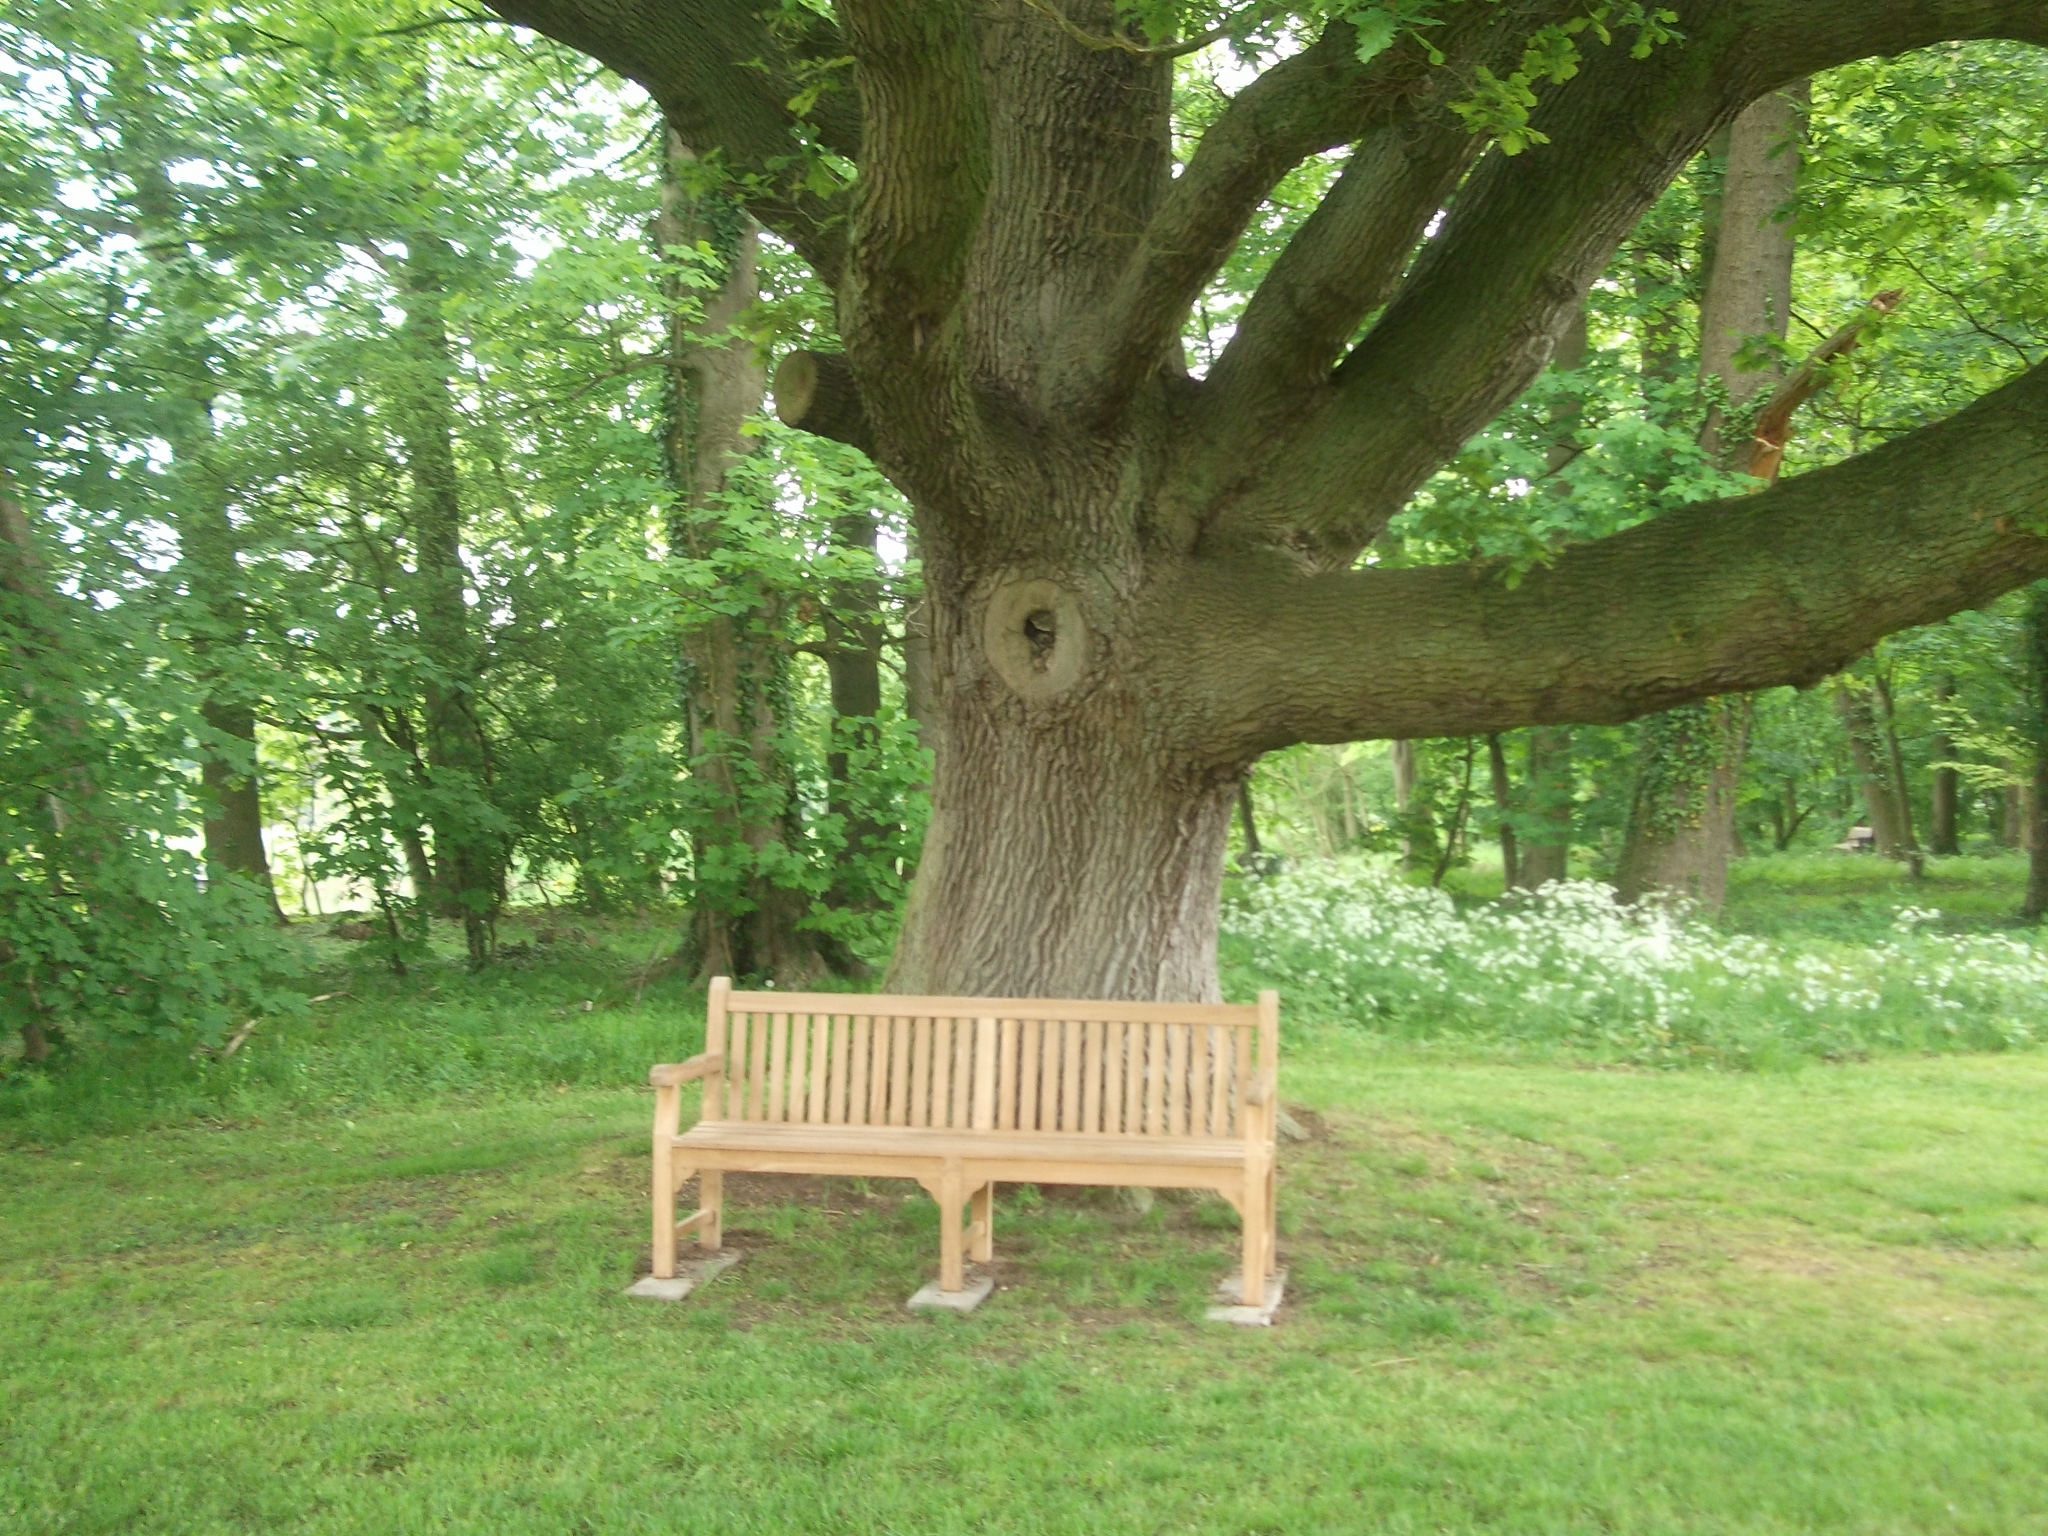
[702, 977, 1280, 1139]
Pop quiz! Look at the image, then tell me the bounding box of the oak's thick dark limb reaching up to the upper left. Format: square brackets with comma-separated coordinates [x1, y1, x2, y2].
[489, 0, 860, 283]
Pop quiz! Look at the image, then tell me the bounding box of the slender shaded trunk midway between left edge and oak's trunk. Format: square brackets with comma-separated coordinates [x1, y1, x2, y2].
[397, 231, 506, 967]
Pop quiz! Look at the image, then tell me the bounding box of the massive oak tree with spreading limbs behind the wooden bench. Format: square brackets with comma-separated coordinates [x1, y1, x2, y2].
[494, 0, 2048, 997]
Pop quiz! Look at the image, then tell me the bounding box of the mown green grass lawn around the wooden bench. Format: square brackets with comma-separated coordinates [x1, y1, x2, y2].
[0, 1032, 2048, 1536]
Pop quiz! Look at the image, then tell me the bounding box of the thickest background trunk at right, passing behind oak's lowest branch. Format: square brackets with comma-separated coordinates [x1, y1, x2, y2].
[1616, 86, 1804, 911]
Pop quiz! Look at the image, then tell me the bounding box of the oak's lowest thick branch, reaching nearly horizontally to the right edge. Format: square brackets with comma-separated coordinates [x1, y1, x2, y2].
[1161, 354, 2048, 752]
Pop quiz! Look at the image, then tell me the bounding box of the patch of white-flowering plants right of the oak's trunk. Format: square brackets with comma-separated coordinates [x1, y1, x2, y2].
[1223, 860, 2048, 1067]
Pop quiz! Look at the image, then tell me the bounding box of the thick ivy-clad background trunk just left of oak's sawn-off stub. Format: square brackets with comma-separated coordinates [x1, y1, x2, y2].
[653, 127, 831, 985]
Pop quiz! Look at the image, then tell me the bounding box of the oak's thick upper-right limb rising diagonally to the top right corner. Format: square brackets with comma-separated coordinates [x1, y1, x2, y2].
[1208, 0, 2048, 567]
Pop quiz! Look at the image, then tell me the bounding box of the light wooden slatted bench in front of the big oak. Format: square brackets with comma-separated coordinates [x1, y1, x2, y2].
[647, 977, 1280, 1307]
